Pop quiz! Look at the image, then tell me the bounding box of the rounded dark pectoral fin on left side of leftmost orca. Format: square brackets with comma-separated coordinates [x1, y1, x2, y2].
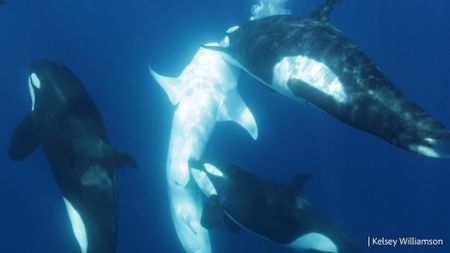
[8, 113, 39, 161]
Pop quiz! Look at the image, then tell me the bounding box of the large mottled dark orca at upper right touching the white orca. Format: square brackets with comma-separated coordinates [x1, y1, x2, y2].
[205, 0, 450, 158]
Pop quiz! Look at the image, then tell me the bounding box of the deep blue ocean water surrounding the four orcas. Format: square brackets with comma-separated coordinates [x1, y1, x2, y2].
[0, 0, 450, 253]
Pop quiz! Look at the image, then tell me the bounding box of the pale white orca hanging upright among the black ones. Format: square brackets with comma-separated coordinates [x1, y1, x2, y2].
[150, 43, 258, 253]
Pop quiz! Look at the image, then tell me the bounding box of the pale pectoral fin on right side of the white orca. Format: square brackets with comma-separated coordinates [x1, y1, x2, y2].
[216, 90, 258, 140]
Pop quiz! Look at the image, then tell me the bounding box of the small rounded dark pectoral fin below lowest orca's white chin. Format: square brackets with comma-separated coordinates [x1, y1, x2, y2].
[200, 195, 224, 230]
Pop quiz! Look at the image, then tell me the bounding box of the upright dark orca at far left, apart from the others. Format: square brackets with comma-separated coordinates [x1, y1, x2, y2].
[9, 60, 136, 253]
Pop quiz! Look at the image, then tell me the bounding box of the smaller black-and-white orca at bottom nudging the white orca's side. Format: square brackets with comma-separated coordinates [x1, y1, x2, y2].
[190, 162, 361, 253]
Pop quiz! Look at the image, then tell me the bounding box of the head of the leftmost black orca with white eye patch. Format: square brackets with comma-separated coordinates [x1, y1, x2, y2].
[28, 60, 79, 111]
